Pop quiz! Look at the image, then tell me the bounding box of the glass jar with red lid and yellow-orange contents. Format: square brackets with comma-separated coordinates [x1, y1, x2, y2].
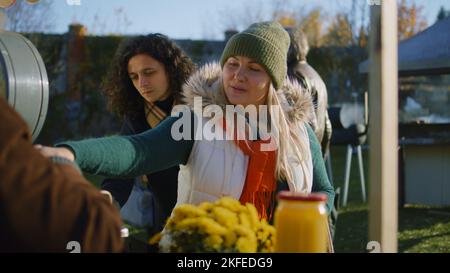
[274, 191, 328, 253]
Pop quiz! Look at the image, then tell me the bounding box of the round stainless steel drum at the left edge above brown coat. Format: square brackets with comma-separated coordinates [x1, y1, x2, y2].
[0, 31, 49, 140]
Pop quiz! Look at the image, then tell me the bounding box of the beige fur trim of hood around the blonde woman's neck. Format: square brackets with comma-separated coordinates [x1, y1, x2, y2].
[182, 63, 315, 124]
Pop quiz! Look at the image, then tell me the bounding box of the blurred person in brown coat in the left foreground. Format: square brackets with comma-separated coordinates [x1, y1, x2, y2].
[0, 97, 123, 252]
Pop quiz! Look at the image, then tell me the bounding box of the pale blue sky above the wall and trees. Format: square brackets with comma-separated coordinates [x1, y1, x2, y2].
[48, 0, 450, 40]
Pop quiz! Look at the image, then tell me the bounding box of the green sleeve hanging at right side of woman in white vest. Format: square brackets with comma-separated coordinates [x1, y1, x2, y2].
[306, 125, 334, 212]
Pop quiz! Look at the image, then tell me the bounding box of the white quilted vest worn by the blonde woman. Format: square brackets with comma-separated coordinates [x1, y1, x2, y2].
[177, 117, 313, 206]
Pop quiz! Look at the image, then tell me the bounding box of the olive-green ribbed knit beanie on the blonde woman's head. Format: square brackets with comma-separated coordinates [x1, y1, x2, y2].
[220, 22, 290, 89]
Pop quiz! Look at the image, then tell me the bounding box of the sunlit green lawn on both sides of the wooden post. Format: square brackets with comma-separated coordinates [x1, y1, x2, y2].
[331, 147, 450, 253]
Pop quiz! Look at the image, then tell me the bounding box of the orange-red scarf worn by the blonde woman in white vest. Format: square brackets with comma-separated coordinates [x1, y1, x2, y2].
[222, 120, 277, 220]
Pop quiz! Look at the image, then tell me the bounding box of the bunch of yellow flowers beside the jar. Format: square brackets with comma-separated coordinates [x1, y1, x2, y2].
[150, 197, 275, 252]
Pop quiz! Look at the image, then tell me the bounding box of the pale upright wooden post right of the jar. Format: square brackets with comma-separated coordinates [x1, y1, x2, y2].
[369, 0, 398, 252]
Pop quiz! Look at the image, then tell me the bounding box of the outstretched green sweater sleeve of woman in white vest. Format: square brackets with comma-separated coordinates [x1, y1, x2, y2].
[56, 114, 194, 178]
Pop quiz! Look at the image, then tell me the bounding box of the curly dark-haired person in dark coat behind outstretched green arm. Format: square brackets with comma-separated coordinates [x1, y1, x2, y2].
[102, 33, 195, 234]
